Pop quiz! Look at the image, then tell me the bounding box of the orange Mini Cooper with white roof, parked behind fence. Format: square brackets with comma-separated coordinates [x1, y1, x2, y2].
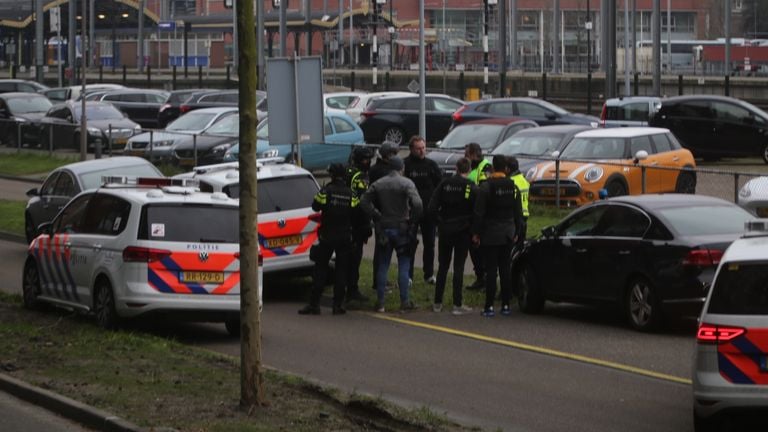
[526, 127, 696, 206]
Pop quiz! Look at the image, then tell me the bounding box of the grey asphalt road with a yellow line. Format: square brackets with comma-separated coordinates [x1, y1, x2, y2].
[0, 241, 693, 431]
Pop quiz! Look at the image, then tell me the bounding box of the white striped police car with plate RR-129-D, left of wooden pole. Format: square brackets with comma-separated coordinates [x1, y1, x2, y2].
[23, 177, 260, 334]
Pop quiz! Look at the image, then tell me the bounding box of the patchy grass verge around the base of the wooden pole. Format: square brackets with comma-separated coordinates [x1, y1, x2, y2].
[0, 294, 477, 432]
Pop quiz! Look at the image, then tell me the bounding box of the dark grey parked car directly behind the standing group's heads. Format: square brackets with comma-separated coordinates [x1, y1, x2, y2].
[427, 118, 538, 175]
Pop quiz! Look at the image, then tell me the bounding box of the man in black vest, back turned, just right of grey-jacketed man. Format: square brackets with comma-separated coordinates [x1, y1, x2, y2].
[428, 158, 477, 315]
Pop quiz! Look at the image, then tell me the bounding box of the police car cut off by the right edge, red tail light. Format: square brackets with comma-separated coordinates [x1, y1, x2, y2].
[693, 219, 768, 432]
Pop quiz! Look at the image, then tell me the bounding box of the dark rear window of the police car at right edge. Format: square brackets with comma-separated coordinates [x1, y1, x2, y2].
[707, 262, 768, 315]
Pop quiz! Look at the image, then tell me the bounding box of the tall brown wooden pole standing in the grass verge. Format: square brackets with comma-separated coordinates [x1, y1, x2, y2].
[235, 0, 266, 411]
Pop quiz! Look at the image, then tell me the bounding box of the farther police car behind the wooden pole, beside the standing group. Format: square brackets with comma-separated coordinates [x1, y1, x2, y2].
[174, 157, 320, 273]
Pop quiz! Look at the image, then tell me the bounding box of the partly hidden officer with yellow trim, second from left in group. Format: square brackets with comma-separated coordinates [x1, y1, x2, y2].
[347, 146, 373, 302]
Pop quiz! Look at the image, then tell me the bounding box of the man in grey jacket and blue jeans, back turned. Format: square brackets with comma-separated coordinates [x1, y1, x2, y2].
[360, 156, 423, 312]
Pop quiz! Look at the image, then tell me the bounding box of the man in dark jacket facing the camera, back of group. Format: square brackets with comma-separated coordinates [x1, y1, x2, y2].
[403, 135, 443, 284]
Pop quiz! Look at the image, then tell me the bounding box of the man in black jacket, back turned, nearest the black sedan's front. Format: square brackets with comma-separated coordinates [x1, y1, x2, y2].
[472, 155, 523, 317]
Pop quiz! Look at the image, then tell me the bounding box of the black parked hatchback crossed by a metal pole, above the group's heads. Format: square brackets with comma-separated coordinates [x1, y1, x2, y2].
[360, 94, 464, 145]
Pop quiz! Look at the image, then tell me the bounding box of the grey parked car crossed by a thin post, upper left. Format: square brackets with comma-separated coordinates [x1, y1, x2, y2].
[39, 101, 141, 150]
